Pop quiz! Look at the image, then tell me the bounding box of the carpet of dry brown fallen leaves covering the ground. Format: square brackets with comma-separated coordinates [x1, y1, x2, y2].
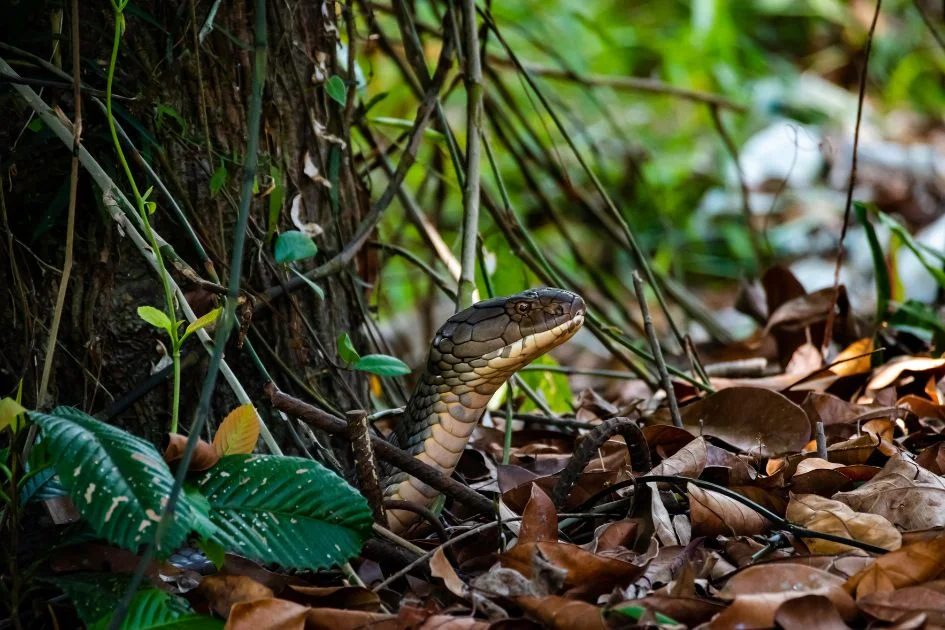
[49, 270, 945, 630]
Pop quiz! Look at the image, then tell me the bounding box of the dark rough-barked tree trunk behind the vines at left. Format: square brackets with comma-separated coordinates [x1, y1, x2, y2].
[0, 0, 370, 450]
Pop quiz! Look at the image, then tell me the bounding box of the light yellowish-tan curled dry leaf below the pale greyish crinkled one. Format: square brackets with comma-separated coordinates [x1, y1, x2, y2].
[786, 493, 902, 554]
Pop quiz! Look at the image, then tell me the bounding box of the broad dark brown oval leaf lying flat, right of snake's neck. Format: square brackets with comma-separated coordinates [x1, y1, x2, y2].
[680, 387, 810, 457]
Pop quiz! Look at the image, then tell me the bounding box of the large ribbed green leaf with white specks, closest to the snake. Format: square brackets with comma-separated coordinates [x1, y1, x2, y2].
[197, 455, 373, 569]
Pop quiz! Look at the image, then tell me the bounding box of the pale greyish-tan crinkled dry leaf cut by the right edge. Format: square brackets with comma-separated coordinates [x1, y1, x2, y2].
[834, 455, 945, 531]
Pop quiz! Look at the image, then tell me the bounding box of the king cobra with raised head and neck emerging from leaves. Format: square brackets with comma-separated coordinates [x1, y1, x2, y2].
[384, 288, 584, 532]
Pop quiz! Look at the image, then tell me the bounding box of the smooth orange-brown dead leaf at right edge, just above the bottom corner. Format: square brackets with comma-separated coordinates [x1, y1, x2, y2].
[845, 537, 945, 599]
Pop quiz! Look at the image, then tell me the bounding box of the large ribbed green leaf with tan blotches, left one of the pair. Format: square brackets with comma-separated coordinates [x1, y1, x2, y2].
[29, 407, 194, 555]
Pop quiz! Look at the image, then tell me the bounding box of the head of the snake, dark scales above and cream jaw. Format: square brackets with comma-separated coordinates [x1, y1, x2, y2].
[430, 288, 585, 378]
